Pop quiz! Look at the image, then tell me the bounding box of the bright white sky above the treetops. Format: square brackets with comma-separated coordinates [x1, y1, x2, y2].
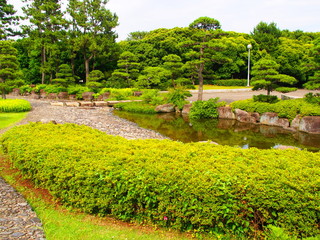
[8, 0, 320, 40]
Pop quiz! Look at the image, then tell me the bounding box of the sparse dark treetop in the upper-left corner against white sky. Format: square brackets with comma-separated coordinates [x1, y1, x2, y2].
[0, 0, 19, 40]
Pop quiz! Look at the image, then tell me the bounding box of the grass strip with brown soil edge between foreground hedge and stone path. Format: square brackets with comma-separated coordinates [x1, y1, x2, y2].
[0, 153, 195, 240]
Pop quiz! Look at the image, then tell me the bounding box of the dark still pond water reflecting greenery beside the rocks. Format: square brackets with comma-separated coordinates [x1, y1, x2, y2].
[114, 111, 320, 151]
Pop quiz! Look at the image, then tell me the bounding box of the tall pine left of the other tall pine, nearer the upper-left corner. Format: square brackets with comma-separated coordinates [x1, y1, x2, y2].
[23, 0, 66, 83]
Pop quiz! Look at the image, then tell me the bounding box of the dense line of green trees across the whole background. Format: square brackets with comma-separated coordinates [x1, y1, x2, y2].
[0, 0, 320, 98]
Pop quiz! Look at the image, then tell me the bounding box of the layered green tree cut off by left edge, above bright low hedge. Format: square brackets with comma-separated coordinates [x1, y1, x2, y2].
[0, 41, 19, 99]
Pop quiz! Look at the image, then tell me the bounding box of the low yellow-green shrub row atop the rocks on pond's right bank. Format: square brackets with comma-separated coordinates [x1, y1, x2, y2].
[230, 99, 320, 120]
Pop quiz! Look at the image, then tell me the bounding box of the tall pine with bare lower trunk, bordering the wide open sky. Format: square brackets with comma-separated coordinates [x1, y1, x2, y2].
[67, 0, 118, 81]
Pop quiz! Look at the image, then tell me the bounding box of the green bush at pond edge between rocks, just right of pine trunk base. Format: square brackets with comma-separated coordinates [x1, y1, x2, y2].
[189, 98, 226, 119]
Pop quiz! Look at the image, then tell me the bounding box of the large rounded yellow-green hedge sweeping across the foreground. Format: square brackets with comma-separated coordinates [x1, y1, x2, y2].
[0, 123, 320, 238]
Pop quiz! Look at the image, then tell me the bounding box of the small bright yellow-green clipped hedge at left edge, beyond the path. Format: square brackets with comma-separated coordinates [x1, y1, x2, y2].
[0, 99, 31, 113]
